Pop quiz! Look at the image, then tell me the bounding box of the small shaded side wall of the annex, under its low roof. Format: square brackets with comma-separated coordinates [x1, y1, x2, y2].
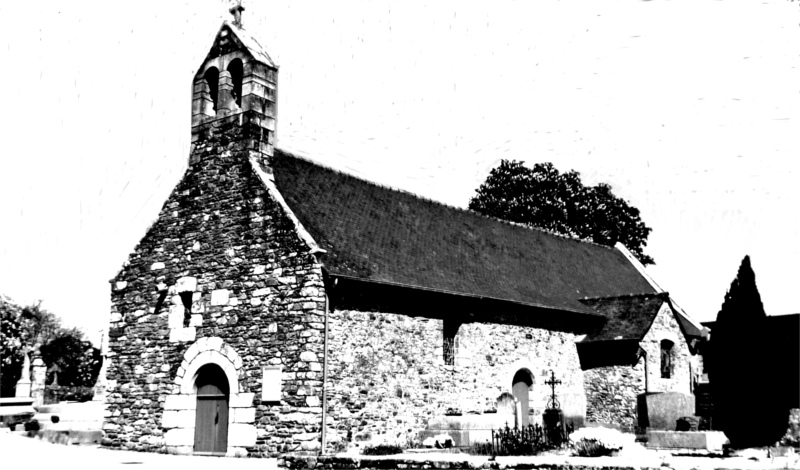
[583, 359, 645, 431]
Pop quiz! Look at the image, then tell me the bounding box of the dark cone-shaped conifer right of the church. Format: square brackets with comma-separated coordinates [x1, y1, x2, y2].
[708, 256, 789, 448]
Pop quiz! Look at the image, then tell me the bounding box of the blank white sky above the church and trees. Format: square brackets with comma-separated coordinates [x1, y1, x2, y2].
[0, 0, 800, 346]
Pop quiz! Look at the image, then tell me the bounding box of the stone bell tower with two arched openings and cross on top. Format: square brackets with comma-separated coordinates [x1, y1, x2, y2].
[192, 4, 278, 157]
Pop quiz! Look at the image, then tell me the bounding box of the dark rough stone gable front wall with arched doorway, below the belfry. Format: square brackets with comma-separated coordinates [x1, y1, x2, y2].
[103, 113, 325, 457]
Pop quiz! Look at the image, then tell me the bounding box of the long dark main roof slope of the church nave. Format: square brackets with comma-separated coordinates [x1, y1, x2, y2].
[272, 151, 654, 312]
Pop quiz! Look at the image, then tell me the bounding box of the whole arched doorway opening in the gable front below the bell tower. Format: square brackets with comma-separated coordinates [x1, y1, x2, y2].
[194, 364, 230, 455]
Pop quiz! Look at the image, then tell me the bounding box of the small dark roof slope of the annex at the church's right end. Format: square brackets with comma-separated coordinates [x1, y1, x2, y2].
[581, 292, 669, 342]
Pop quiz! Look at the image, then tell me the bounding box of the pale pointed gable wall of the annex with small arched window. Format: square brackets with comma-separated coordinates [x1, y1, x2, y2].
[639, 303, 692, 394]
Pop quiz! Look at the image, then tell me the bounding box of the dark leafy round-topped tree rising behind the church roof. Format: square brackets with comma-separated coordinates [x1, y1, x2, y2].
[469, 160, 654, 265]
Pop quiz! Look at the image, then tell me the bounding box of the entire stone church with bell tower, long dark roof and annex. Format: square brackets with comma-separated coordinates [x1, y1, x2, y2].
[103, 17, 700, 458]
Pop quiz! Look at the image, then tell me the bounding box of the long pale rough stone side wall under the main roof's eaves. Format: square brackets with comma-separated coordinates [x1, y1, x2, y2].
[328, 311, 586, 450]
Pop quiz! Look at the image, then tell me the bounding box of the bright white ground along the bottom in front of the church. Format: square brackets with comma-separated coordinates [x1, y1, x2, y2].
[0, 432, 800, 470]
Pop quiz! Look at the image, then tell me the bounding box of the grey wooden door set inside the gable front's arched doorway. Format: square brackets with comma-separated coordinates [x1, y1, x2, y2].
[194, 370, 228, 455]
